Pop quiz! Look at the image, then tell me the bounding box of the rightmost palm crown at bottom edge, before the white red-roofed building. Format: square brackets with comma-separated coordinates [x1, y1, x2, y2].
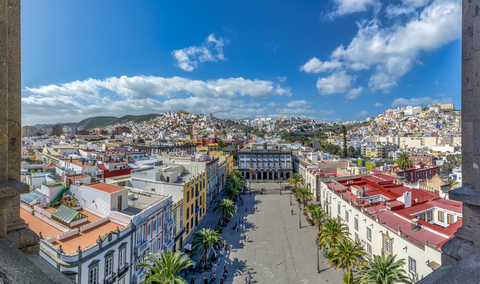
[360, 252, 412, 284]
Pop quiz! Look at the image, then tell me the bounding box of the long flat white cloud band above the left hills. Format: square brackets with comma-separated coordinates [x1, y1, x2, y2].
[26, 76, 291, 99]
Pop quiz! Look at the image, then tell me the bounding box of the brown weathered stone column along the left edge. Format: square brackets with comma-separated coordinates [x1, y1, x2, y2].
[0, 0, 39, 254]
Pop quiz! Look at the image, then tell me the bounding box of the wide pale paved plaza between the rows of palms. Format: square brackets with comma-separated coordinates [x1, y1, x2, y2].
[182, 183, 343, 284]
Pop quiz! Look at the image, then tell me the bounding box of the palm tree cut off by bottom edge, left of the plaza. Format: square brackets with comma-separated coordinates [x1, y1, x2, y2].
[136, 251, 193, 284]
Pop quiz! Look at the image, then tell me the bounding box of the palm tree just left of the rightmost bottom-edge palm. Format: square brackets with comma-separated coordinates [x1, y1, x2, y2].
[328, 239, 365, 284]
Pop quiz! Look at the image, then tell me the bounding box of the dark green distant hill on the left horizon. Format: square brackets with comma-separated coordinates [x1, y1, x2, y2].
[35, 113, 159, 130]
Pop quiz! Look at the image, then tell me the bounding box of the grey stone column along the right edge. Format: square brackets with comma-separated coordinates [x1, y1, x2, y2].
[442, 0, 480, 265]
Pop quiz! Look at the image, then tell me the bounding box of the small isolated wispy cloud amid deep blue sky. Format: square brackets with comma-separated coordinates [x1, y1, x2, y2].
[172, 34, 229, 72]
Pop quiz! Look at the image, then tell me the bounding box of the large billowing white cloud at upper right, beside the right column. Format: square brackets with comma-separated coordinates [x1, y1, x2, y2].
[308, 0, 462, 93]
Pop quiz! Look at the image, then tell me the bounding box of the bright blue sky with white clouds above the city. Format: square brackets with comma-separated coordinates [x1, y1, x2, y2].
[22, 0, 461, 125]
